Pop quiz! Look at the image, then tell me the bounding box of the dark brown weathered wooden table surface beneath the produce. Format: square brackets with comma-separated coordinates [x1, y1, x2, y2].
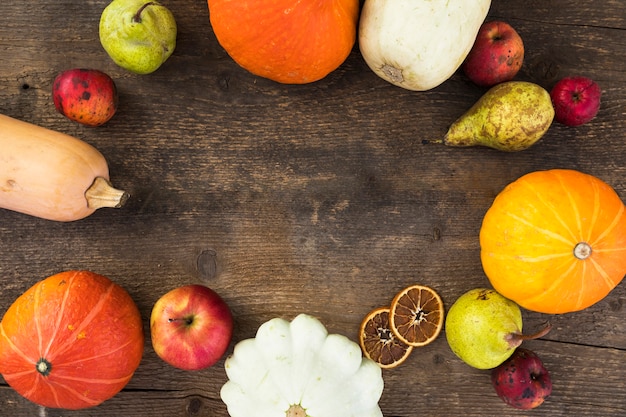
[0, 0, 626, 417]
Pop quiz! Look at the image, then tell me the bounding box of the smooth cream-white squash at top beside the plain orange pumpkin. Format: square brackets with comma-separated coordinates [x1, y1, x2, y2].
[359, 0, 491, 91]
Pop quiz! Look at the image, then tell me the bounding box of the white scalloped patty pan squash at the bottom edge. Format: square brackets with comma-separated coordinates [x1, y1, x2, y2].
[220, 314, 383, 417]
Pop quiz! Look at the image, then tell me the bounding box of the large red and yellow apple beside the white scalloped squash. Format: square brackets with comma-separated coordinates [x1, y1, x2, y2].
[150, 284, 233, 371]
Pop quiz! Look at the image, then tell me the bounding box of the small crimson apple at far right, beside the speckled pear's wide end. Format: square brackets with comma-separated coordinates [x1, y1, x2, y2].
[550, 77, 602, 126]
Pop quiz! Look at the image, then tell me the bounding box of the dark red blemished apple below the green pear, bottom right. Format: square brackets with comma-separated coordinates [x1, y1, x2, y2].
[491, 348, 552, 410]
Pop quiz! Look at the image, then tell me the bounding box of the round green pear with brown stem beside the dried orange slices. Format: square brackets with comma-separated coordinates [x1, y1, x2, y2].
[445, 288, 550, 369]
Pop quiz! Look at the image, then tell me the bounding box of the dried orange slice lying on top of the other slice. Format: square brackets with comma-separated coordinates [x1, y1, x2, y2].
[389, 285, 444, 346]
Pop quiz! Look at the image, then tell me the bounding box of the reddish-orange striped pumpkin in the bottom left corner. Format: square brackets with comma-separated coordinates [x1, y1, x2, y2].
[0, 271, 144, 409]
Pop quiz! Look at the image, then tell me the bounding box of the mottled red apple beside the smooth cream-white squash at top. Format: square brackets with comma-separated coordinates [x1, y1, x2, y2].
[462, 20, 524, 87]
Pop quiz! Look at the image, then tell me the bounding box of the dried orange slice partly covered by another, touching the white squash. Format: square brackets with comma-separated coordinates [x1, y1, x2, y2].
[359, 307, 413, 368]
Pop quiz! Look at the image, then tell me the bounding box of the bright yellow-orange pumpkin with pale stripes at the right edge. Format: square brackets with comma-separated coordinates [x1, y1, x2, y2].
[480, 169, 626, 314]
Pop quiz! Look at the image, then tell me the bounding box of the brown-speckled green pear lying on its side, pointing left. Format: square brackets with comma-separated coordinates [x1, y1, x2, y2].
[443, 81, 554, 152]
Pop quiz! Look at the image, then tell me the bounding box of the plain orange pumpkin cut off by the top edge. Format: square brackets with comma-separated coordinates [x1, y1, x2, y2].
[208, 0, 359, 84]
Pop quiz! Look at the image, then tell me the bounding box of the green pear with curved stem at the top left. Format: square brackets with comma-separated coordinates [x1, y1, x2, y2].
[100, 0, 177, 74]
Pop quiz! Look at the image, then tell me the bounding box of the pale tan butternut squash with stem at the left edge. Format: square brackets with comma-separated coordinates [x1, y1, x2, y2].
[0, 115, 129, 222]
